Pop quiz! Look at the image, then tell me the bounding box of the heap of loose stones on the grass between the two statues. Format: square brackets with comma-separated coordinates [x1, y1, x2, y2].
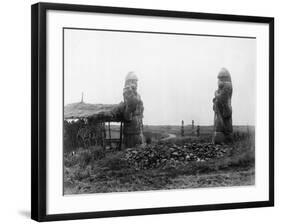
[125, 142, 230, 169]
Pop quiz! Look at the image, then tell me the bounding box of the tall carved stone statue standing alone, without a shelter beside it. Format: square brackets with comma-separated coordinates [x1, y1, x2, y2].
[213, 68, 233, 144]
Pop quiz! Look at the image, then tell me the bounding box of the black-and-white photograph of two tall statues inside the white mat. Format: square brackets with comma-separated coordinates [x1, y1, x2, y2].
[62, 27, 257, 195]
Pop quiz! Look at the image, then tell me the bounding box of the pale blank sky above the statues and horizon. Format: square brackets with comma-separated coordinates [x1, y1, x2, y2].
[64, 29, 256, 125]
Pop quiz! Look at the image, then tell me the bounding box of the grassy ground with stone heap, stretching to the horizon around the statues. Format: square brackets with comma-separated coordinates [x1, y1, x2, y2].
[64, 126, 255, 194]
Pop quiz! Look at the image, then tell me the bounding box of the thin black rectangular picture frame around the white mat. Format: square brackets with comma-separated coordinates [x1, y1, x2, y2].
[31, 3, 274, 221]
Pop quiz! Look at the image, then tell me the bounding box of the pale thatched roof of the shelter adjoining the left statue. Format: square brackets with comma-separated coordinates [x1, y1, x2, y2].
[64, 102, 117, 119]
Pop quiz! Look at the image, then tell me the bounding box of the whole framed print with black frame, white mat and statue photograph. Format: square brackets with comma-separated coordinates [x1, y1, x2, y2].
[31, 3, 274, 221]
